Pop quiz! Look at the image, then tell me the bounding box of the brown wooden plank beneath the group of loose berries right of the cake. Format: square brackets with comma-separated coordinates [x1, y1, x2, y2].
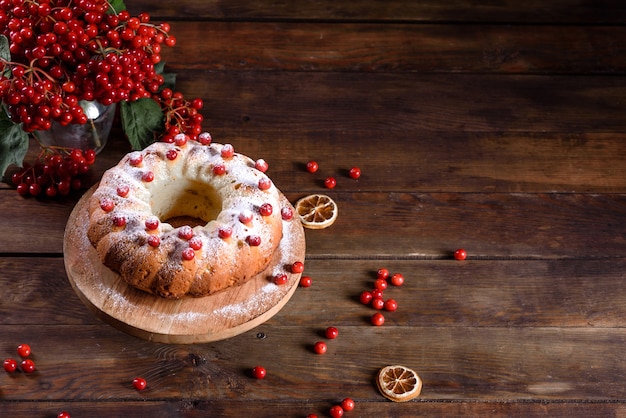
[0, 253, 626, 328]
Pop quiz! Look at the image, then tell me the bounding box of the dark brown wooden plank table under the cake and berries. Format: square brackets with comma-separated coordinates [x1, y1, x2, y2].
[0, 0, 626, 418]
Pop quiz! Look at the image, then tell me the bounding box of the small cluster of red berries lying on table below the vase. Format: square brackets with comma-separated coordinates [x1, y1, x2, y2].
[11, 148, 96, 197]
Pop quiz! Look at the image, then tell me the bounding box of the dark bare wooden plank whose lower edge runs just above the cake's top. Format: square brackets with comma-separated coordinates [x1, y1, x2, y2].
[173, 70, 626, 134]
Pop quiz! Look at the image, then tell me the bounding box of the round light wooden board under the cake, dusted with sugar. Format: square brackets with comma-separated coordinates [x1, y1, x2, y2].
[63, 186, 306, 344]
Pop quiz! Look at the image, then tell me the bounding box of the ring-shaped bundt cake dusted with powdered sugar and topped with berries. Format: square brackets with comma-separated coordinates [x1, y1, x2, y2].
[88, 141, 283, 299]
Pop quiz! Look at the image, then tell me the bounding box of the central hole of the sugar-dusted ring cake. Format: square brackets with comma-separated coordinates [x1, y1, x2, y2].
[151, 180, 222, 228]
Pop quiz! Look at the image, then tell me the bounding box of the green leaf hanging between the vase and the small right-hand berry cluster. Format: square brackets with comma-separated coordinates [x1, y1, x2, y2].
[120, 98, 165, 150]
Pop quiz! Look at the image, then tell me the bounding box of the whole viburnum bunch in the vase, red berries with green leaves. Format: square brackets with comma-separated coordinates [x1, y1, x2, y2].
[0, 0, 203, 190]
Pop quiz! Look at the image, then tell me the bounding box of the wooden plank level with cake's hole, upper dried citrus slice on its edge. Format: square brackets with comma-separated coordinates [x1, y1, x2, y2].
[0, 190, 626, 259]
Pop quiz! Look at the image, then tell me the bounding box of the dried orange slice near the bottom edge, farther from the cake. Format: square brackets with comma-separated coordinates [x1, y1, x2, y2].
[376, 366, 422, 402]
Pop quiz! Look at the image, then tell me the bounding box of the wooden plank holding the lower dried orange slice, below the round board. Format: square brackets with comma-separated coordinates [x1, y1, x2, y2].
[0, 321, 626, 402]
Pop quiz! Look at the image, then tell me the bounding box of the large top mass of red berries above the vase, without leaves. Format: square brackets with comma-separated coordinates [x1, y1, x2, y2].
[0, 0, 176, 132]
